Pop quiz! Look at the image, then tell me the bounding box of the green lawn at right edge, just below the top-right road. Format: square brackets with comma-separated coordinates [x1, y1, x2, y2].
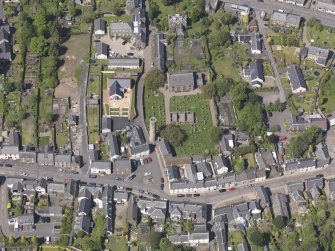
[307, 26, 335, 49]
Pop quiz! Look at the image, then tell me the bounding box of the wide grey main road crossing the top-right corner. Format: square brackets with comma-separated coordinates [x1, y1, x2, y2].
[221, 0, 335, 27]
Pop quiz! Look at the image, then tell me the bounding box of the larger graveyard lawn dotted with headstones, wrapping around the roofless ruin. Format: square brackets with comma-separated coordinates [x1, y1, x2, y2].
[170, 94, 215, 156]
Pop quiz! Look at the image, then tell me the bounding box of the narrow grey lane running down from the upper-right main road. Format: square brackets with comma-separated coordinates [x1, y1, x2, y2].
[256, 11, 286, 103]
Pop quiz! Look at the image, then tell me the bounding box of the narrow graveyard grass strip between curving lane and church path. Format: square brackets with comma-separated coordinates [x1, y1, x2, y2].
[144, 88, 165, 132]
